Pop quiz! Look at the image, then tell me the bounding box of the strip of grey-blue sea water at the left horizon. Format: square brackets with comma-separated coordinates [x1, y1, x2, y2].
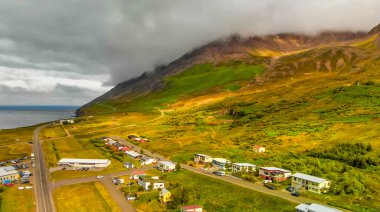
[0, 106, 78, 129]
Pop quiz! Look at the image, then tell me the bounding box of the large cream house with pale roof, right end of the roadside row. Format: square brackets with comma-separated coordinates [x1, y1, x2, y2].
[292, 173, 330, 194]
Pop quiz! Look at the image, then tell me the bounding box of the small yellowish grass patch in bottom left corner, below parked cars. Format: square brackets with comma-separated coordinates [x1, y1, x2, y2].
[0, 186, 35, 212]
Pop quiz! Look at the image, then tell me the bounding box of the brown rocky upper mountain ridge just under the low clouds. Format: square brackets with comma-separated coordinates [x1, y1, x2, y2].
[77, 25, 379, 115]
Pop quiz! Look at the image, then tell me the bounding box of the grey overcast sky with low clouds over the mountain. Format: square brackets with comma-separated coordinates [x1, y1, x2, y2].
[0, 0, 380, 105]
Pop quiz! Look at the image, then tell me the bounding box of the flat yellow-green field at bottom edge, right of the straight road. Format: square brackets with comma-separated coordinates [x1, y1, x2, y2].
[53, 182, 121, 212]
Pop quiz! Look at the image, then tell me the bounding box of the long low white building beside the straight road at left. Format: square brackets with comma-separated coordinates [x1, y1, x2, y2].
[58, 158, 111, 168]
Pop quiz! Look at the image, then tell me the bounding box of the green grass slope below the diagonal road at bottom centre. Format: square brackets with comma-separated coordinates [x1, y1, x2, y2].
[134, 170, 297, 211]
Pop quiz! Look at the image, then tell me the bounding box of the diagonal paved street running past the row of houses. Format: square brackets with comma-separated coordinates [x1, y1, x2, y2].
[112, 137, 347, 211]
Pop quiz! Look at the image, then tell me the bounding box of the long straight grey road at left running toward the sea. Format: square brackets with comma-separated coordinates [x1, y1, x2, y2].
[33, 126, 55, 212]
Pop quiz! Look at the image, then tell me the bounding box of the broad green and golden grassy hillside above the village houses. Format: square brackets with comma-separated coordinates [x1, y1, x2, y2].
[70, 32, 380, 211]
